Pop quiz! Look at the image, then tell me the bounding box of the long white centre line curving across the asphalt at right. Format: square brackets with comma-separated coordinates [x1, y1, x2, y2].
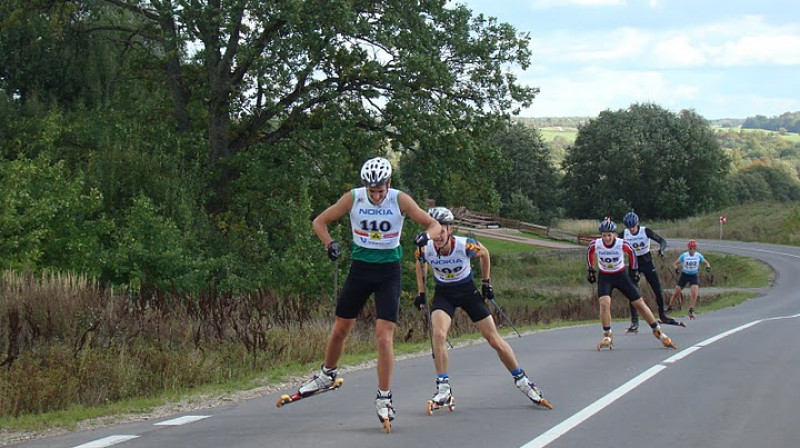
[520, 314, 800, 448]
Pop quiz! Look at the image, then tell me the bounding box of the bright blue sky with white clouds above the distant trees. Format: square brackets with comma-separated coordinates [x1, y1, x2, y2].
[457, 0, 800, 120]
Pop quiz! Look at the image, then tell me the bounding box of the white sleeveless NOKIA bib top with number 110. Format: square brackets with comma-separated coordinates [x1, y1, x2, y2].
[350, 187, 404, 249]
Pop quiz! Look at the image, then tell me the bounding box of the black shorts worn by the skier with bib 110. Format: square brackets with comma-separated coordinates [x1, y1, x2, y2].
[336, 260, 401, 322]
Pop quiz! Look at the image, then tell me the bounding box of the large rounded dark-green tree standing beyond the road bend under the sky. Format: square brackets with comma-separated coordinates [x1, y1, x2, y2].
[563, 104, 730, 219]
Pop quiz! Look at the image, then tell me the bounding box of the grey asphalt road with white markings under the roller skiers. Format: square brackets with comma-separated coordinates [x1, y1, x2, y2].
[7, 241, 800, 448]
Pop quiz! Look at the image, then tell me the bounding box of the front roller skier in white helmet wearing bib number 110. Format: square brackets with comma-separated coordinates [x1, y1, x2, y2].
[278, 157, 441, 433]
